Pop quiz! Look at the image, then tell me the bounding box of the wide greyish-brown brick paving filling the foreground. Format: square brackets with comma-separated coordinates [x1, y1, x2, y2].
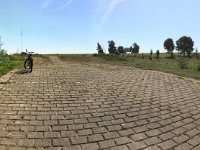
[0, 57, 200, 150]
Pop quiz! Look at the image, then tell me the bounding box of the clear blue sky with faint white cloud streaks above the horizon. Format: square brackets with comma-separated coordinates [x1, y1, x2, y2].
[0, 0, 200, 53]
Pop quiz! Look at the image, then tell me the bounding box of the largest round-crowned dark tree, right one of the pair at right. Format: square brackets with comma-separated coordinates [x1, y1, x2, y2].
[176, 36, 194, 57]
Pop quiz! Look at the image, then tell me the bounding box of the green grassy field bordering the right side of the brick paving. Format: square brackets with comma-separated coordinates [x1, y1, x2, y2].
[59, 53, 200, 80]
